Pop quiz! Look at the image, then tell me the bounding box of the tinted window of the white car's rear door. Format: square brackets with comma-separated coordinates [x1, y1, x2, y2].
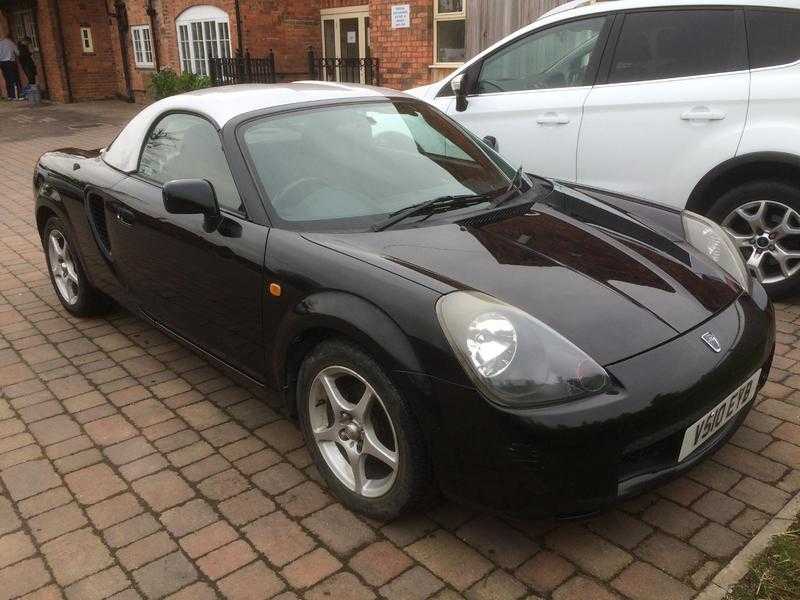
[608, 10, 747, 83]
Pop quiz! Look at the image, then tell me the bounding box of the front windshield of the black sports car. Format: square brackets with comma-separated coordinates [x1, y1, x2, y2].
[241, 100, 514, 229]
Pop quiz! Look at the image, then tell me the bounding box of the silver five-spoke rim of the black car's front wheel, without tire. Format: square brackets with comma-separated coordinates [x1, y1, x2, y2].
[308, 366, 400, 498]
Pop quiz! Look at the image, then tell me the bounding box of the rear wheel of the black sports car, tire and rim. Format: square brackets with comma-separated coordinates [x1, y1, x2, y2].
[42, 217, 113, 317]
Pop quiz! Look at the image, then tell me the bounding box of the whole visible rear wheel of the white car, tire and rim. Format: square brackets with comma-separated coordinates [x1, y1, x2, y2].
[708, 180, 800, 298]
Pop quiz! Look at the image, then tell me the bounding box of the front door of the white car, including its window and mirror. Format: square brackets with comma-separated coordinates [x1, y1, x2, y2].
[434, 16, 609, 181]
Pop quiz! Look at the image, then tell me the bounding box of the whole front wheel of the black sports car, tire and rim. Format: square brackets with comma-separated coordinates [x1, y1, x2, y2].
[297, 340, 434, 520]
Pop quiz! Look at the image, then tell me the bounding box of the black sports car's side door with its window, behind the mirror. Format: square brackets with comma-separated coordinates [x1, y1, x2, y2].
[101, 112, 269, 379]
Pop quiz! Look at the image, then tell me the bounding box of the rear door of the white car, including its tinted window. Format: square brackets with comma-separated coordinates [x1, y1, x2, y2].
[578, 9, 750, 208]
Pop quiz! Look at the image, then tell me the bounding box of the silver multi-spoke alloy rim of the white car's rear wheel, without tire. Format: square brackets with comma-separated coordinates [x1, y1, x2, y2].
[722, 200, 800, 284]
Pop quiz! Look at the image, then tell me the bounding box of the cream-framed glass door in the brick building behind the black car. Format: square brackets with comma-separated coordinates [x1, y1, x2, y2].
[321, 6, 372, 83]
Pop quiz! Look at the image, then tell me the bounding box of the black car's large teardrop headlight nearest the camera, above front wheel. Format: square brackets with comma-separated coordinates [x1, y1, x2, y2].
[436, 292, 608, 407]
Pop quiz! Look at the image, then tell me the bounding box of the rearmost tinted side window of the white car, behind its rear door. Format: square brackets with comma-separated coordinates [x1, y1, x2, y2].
[747, 10, 800, 69]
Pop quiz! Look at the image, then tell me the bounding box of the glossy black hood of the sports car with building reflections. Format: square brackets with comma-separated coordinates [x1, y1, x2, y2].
[306, 187, 740, 365]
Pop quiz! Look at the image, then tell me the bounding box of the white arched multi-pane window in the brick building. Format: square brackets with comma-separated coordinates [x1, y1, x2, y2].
[175, 5, 231, 75]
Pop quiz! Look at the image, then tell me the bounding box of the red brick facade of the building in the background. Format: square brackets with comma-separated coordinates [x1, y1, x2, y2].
[3, 0, 444, 101]
